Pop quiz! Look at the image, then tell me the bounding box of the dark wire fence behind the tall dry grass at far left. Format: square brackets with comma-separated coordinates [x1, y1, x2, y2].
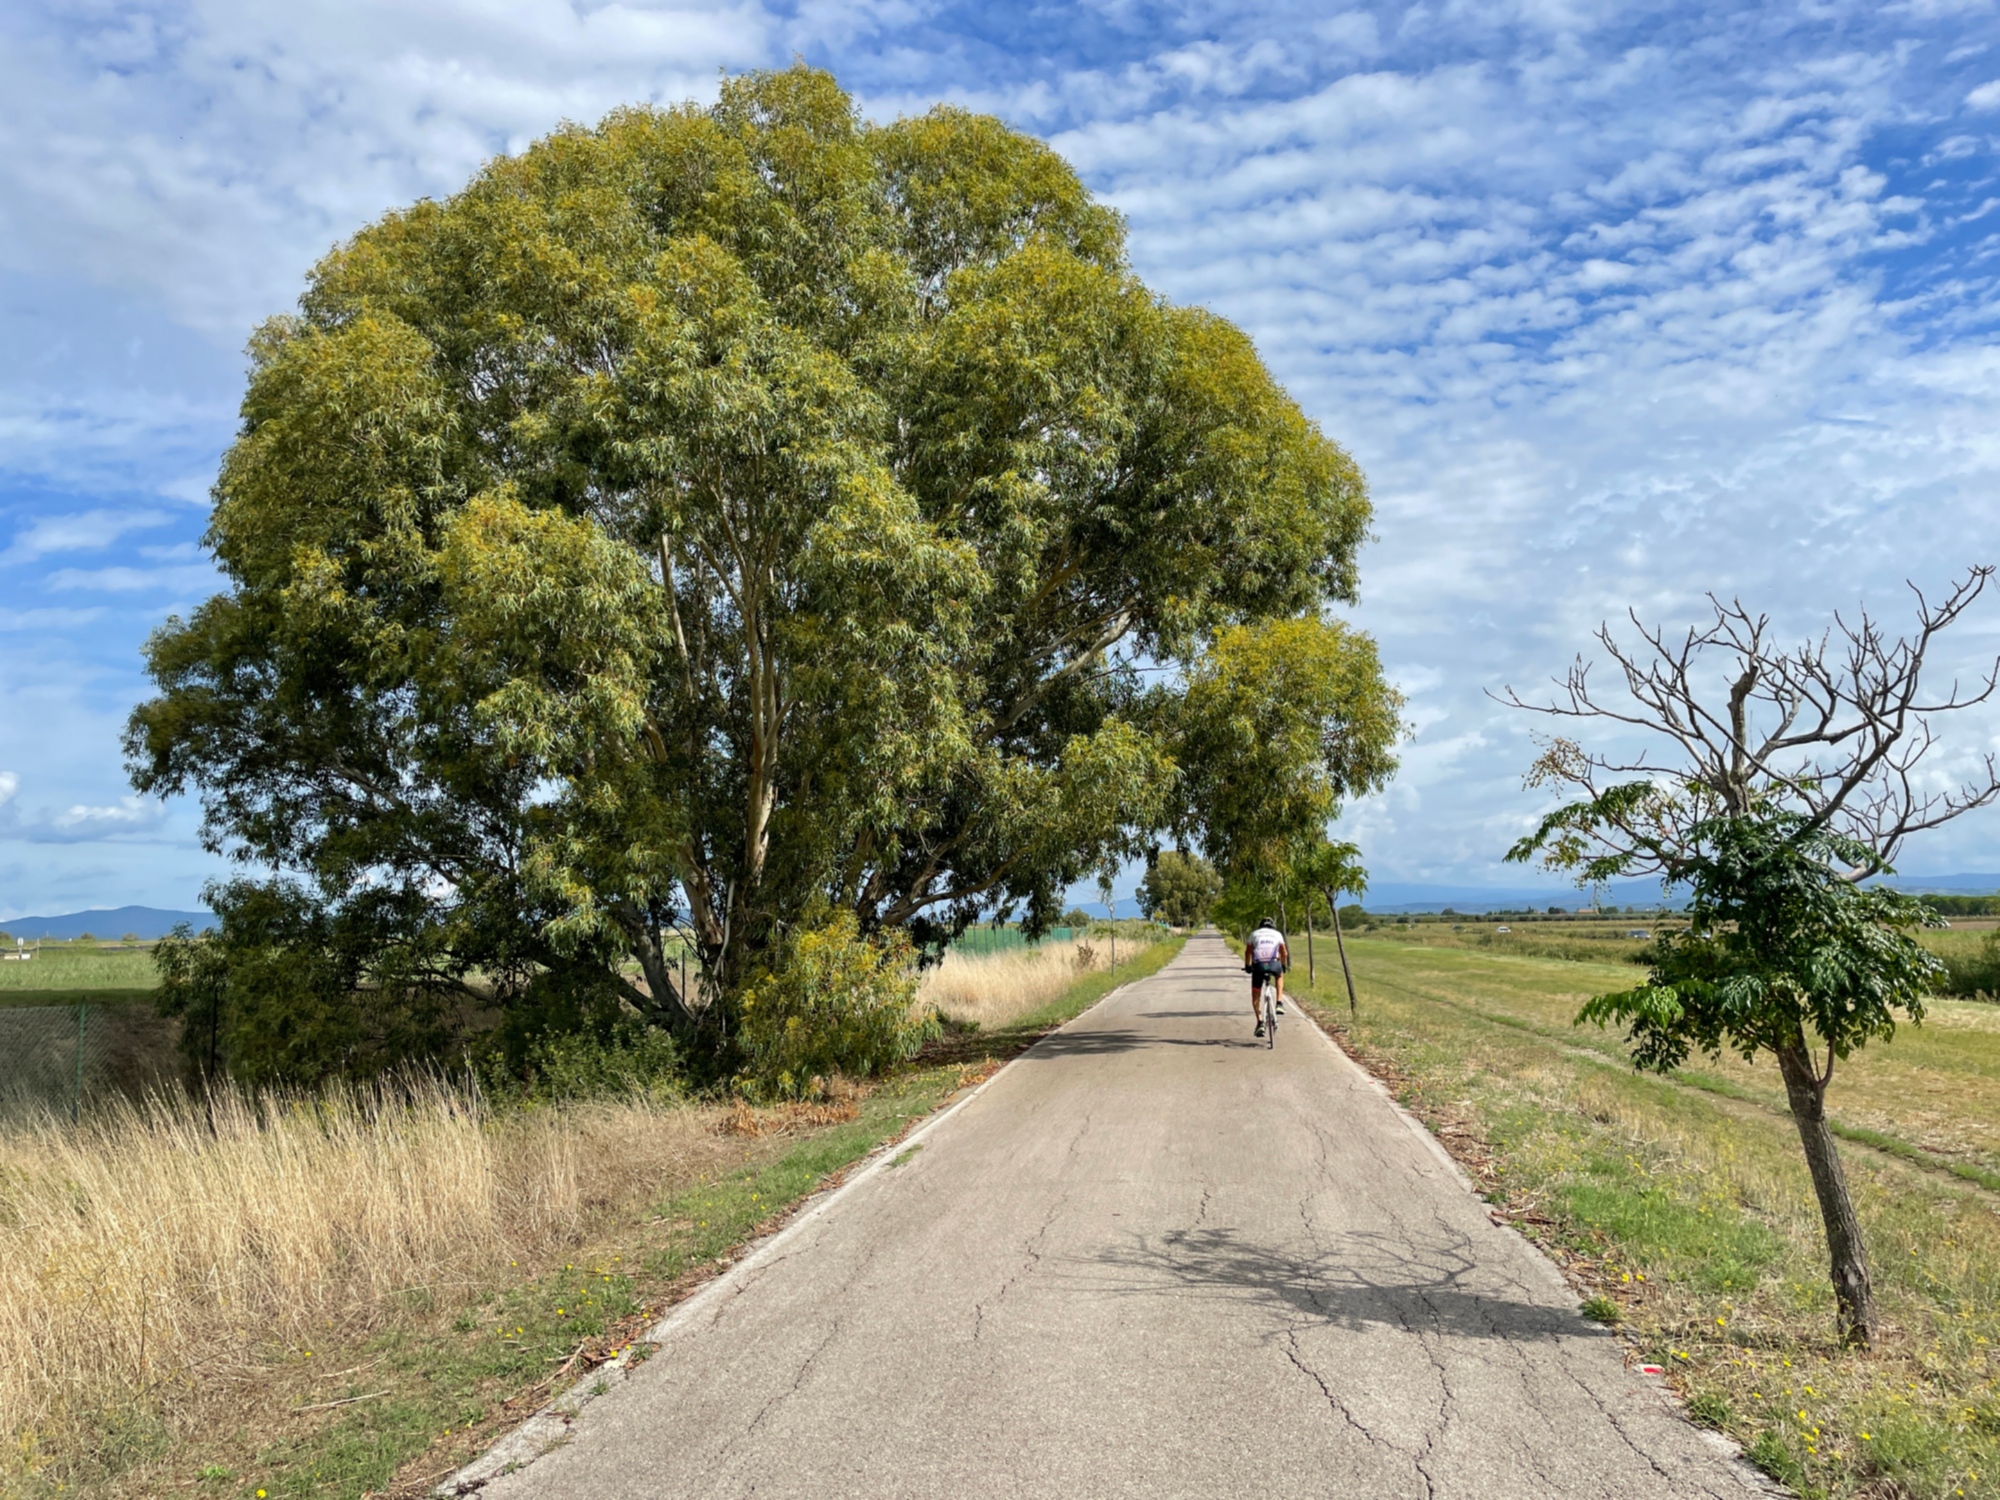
[0, 1002, 180, 1120]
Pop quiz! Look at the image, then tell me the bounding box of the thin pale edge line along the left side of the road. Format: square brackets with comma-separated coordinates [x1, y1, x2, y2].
[432, 944, 1184, 1496]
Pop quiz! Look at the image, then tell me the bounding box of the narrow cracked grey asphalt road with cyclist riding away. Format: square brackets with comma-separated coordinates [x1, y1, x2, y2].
[468, 938, 1764, 1500]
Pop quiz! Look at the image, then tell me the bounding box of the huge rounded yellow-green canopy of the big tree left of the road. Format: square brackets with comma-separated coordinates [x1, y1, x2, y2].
[128, 66, 1396, 1080]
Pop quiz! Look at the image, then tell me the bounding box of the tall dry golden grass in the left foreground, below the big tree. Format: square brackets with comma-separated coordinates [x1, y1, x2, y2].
[0, 1084, 744, 1488]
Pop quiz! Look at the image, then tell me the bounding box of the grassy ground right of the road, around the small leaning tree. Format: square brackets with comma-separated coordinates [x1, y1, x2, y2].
[1298, 932, 2000, 1500]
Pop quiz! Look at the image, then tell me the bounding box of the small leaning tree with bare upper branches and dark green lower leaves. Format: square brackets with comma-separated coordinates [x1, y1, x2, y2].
[1506, 568, 2000, 1344]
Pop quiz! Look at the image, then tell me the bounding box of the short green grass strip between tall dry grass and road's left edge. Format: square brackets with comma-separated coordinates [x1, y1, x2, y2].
[176, 938, 1184, 1500]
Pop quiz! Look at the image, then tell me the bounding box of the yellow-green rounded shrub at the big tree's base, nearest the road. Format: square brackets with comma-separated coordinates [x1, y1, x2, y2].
[738, 912, 938, 1098]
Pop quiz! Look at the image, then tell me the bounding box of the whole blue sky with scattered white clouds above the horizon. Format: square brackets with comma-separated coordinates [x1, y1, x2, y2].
[0, 0, 2000, 918]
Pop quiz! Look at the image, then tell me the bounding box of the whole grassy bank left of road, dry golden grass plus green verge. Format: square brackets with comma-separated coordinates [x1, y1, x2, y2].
[0, 942, 1178, 1500]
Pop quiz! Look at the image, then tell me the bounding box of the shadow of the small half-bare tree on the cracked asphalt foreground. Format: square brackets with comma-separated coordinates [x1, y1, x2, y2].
[1088, 1228, 1598, 1340]
